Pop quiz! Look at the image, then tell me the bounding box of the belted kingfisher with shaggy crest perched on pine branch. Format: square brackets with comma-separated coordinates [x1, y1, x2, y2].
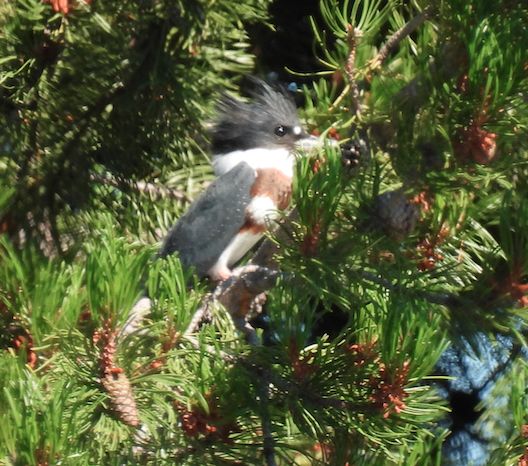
[160, 80, 316, 280]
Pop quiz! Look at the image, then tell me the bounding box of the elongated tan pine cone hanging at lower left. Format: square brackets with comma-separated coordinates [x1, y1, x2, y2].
[102, 367, 139, 427]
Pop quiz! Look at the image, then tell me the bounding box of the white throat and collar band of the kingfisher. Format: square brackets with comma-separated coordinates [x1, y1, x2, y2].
[212, 148, 295, 178]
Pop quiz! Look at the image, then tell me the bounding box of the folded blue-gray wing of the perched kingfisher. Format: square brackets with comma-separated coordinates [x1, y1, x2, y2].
[160, 162, 256, 276]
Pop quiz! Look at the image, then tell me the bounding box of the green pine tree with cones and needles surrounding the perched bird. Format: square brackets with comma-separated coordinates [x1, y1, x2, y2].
[0, 0, 528, 466]
